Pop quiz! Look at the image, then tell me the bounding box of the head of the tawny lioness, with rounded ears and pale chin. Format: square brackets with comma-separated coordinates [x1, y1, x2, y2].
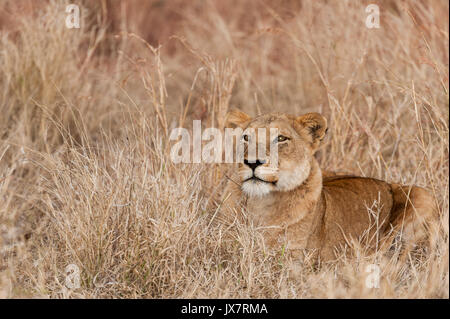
[227, 111, 327, 196]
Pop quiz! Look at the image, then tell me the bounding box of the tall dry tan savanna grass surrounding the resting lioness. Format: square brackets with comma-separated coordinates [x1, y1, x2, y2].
[0, 0, 449, 298]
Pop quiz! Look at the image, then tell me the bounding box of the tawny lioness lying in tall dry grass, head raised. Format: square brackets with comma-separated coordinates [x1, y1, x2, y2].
[223, 111, 434, 261]
